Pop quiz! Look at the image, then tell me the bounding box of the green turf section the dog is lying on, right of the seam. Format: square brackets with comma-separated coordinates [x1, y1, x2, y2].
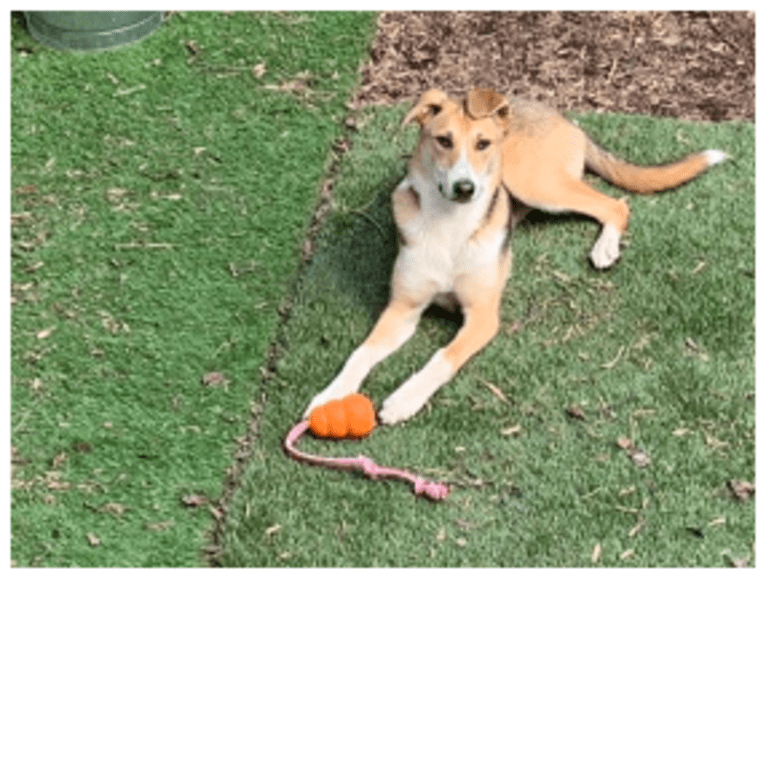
[222, 109, 755, 567]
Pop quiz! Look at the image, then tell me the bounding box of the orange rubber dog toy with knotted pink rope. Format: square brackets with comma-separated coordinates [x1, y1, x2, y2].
[284, 394, 449, 500]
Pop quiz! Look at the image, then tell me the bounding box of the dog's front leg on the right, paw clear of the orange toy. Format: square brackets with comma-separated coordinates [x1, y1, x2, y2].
[378, 292, 502, 425]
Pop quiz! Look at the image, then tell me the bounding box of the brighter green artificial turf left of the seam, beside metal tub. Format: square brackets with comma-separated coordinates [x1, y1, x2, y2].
[11, 13, 374, 566]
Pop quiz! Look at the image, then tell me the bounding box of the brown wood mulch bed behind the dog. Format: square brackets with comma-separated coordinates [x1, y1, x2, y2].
[353, 11, 755, 121]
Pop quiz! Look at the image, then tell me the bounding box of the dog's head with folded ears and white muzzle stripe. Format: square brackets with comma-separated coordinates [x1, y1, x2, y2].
[404, 89, 510, 202]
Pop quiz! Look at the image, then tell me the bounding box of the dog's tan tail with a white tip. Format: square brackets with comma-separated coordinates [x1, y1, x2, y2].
[585, 138, 729, 194]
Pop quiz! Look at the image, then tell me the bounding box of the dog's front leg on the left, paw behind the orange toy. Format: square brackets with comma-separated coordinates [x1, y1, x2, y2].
[304, 297, 425, 417]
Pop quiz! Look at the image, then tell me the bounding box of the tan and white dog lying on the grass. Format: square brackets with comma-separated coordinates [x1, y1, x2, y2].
[305, 89, 727, 425]
